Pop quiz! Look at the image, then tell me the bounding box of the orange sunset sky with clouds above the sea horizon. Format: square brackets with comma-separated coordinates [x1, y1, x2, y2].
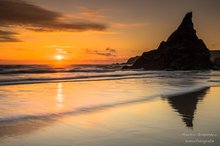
[0, 0, 220, 64]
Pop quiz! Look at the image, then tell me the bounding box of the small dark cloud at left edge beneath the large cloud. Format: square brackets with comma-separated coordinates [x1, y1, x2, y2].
[0, 30, 20, 42]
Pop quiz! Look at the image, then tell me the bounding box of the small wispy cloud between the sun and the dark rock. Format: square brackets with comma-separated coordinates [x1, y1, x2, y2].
[86, 48, 116, 57]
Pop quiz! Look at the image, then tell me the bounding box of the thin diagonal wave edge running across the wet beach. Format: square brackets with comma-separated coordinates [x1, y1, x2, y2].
[0, 86, 211, 124]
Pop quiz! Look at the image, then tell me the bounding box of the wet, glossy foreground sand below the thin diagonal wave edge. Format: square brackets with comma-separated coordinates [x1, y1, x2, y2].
[0, 87, 220, 146]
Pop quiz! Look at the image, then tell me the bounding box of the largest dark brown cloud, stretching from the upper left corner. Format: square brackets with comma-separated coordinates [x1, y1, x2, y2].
[0, 0, 107, 41]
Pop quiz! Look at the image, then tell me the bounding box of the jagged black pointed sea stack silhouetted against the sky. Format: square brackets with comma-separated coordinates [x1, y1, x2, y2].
[131, 12, 212, 70]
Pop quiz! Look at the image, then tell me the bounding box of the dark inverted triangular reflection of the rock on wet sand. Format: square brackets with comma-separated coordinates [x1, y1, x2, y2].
[166, 88, 209, 128]
